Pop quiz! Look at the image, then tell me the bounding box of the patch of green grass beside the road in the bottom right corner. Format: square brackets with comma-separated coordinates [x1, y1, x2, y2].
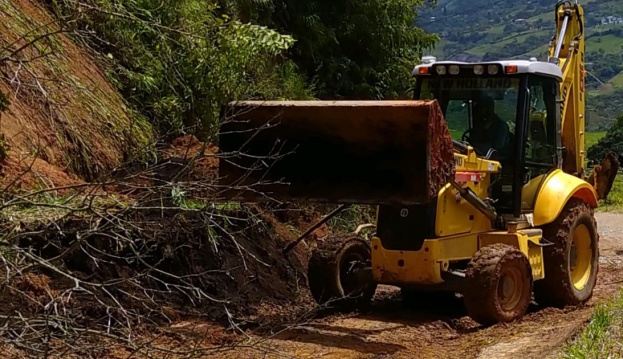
[561, 292, 623, 359]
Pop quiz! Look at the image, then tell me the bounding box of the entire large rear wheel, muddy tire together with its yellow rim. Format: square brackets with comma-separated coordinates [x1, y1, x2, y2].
[534, 198, 599, 308]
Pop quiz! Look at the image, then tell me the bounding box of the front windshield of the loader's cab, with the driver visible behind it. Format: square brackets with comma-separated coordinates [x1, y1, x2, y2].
[419, 77, 520, 158]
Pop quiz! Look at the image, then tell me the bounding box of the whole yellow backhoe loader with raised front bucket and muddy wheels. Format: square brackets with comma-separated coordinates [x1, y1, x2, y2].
[219, 1, 619, 325]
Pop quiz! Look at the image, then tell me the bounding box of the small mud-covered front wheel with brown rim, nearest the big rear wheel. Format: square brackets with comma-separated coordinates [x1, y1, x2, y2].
[464, 244, 532, 326]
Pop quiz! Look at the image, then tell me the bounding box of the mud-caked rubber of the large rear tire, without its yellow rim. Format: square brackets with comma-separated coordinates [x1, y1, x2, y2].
[534, 198, 599, 307]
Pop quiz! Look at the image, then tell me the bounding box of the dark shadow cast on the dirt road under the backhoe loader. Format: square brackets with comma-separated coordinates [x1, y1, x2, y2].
[266, 291, 564, 355]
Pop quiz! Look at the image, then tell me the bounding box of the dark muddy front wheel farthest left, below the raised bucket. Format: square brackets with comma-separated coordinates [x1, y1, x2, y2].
[307, 234, 377, 310]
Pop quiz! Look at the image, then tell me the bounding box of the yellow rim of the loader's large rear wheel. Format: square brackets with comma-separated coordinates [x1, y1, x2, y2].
[569, 224, 593, 290]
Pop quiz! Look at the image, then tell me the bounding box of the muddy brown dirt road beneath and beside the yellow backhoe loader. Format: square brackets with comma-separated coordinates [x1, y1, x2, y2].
[221, 213, 623, 359]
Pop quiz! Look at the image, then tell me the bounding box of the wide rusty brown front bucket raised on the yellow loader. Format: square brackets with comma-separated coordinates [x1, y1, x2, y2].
[219, 100, 454, 205]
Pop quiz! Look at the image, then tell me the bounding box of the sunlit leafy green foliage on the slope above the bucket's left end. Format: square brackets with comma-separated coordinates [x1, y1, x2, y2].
[53, 0, 311, 139]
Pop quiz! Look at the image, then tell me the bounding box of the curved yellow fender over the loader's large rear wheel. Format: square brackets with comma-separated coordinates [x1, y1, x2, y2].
[523, 169, 597, 227]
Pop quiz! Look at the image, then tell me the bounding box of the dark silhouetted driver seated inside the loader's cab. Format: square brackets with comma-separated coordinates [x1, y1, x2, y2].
[469, 96, 511, 158]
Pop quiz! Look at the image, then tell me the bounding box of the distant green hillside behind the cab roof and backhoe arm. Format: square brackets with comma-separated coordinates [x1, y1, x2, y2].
[418, 0, 623, 131]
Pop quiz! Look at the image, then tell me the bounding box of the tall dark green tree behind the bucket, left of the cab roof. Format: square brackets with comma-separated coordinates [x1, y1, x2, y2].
[221, 0, 438, 99]
